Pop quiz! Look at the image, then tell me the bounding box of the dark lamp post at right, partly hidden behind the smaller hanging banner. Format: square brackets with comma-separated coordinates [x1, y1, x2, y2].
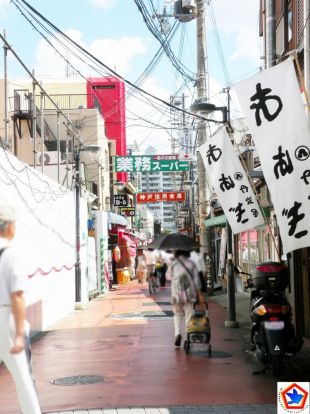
[191, 92, 239, 328]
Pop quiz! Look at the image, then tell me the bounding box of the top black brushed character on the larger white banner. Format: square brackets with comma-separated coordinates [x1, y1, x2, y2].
[250, 83, 283, 126]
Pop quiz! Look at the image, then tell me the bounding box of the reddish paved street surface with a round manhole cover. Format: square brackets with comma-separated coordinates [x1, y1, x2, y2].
[0, 282, 310, 414]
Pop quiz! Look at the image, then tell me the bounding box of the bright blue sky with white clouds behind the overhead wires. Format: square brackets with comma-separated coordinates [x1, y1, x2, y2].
[0, 0, 261, 153]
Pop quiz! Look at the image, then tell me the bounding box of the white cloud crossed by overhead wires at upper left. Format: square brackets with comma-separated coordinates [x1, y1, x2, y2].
[35, 29, 146, 77]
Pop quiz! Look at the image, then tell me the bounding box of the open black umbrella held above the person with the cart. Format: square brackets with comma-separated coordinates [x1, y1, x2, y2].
[148, 233, 199, 250]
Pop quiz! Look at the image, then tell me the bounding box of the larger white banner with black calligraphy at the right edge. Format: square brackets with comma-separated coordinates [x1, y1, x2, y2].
[235, 59, 310, 253]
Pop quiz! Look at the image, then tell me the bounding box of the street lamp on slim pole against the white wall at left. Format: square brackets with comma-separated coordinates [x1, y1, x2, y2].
[73, 145, 101, 303]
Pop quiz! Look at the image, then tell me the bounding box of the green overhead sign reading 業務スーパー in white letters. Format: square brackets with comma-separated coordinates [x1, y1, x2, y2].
[114, 154, 189, 172]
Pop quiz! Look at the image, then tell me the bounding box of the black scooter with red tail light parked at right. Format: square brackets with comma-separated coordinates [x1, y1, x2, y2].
[239, 262, 303, 377]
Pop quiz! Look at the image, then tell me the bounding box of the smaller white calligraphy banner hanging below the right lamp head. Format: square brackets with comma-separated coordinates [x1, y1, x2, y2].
[199, 128, 264, 234]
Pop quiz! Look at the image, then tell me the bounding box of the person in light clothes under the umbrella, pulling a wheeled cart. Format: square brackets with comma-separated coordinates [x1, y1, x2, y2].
[166, 250, 205, 346]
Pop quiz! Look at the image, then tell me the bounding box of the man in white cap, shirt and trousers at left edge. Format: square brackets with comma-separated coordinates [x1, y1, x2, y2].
[0, 205, 41, 414]
